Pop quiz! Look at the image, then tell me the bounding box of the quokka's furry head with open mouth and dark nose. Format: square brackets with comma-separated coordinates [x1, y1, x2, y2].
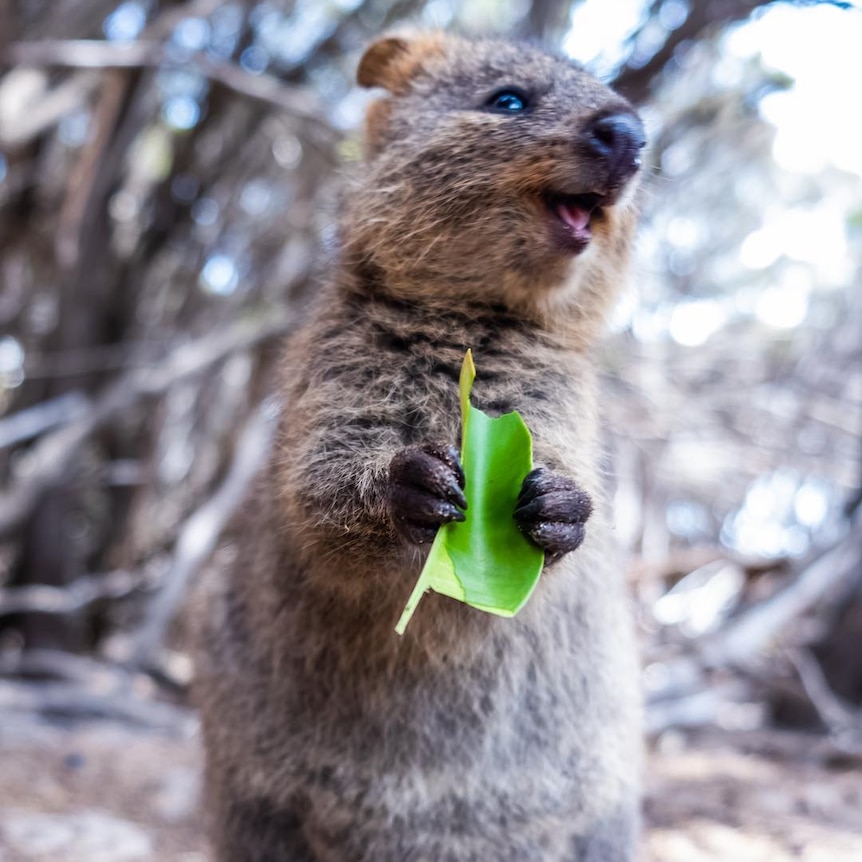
[343, 32, 645, 324]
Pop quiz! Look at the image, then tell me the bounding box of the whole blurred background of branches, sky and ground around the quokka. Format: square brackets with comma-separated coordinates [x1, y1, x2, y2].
[0, 0, 862, 862]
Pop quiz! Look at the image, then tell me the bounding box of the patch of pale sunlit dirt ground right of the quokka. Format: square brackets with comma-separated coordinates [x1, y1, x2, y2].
[643, 733, 862, 862]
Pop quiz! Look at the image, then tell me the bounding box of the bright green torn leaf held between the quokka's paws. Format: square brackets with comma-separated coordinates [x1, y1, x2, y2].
[395, 350, 545, 634]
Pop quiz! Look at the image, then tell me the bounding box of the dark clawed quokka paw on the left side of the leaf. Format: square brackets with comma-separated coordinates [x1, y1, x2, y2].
[387, 444, 467, 545]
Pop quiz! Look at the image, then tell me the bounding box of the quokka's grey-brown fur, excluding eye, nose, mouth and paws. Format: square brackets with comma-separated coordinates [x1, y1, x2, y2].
[197, 34, 640, 862]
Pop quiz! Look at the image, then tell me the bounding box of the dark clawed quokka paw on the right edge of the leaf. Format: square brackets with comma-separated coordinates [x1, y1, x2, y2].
[515, 467, 593, 562]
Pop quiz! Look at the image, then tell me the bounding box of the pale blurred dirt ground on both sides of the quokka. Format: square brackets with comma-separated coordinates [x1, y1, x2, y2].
[0, 723, 862, 862]
